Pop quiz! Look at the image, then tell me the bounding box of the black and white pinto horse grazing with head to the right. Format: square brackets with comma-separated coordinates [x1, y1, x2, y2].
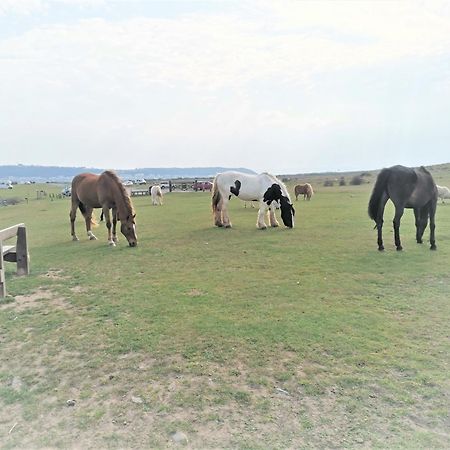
[212, 171, 295, 230]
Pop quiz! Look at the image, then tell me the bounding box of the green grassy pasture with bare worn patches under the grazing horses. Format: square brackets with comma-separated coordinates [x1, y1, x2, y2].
[0, 178, 450, 449]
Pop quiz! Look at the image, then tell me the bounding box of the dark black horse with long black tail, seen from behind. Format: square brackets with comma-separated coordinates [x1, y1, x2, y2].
[369, 166, 437, 250]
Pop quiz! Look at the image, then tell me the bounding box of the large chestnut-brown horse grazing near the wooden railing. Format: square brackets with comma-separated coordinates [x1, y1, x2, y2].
[70, 170, 137, 247]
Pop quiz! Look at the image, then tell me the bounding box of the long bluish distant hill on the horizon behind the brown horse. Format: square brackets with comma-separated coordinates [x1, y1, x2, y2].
[0, 164, 255, 182]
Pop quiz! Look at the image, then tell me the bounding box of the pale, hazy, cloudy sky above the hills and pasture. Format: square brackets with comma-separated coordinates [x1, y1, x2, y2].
[0, 0, 450, 174]
